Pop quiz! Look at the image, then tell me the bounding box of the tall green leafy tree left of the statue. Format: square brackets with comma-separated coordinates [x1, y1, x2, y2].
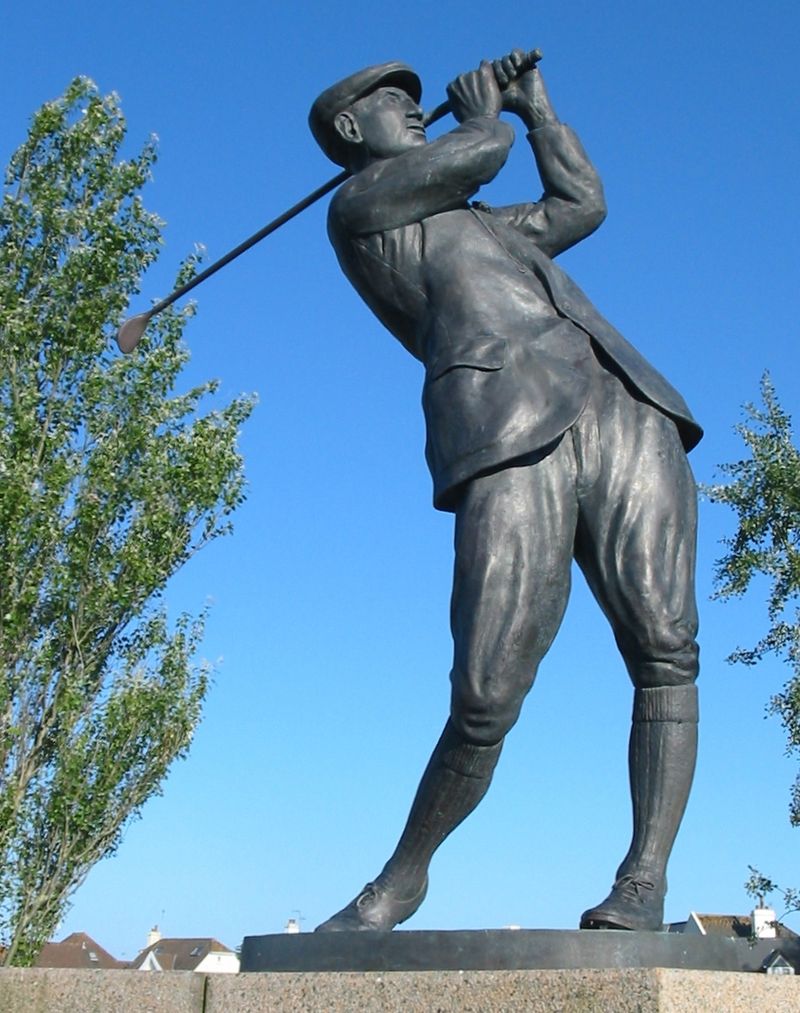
[0, 78, 252, 964]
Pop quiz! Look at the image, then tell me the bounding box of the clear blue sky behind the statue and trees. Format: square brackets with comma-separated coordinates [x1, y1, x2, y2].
[0, 0, 800, 957]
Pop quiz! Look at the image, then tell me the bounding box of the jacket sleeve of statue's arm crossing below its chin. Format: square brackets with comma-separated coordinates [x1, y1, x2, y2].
[331, 116, 513, 236]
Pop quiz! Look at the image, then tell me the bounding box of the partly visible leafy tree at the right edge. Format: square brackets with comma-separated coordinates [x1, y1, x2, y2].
[706, 374, 800, 822]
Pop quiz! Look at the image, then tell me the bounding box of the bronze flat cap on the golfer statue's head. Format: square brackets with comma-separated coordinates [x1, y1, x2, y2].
[308, 60, 422, 165]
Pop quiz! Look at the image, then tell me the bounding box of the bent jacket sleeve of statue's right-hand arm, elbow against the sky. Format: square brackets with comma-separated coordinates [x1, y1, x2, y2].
[491, 123, 606, 257]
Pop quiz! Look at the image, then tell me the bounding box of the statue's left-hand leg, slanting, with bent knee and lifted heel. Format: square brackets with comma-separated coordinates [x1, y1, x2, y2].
[319, 441, 577, 931]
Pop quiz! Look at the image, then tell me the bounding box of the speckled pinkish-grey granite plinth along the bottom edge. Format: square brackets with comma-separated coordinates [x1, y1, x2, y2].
[0, 967, 800, 1013]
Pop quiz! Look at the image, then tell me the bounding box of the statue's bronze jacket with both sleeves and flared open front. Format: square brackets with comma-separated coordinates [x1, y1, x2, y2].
[328, 116, 702, 510]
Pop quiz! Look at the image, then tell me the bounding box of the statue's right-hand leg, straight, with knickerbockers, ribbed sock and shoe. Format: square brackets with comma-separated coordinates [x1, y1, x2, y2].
[576, 368, 698, 930]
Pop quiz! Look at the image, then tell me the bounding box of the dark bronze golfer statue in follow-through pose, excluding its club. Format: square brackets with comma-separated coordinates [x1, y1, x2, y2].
[310, 51, 702, 931]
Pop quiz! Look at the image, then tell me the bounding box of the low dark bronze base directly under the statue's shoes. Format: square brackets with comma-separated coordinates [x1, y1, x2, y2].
[241, 929, 800, 971]
